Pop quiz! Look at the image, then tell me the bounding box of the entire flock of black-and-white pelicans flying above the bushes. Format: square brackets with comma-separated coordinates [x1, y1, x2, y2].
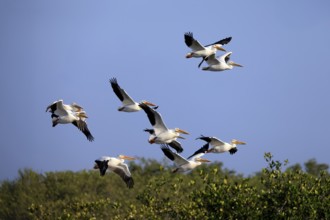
[46, 32, 246, 188]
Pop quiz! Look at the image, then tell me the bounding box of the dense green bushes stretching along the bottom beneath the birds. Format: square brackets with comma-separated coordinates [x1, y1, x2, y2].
[0, 153, 330, 219]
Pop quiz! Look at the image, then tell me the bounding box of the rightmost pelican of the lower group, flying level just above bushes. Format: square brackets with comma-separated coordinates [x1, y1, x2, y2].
[196, 135, 246, 154]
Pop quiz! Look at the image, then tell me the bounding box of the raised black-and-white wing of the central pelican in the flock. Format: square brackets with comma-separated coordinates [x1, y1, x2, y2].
[139, 103, 168, 135]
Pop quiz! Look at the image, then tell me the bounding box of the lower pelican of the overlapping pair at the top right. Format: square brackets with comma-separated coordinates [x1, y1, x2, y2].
[202, 52, 243, 71]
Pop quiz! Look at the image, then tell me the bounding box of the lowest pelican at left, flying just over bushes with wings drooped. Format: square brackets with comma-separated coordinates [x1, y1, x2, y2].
[94, 155, 135, 188]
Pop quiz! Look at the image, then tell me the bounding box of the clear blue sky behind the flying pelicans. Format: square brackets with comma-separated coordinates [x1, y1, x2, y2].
[0, 0, 330, 179]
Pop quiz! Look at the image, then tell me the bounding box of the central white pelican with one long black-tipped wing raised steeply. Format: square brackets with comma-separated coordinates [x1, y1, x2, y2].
[140, 103, 189, 148]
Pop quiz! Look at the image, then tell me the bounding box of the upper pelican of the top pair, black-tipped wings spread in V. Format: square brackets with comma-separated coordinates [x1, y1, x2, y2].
[184, 32, 231, 67]
